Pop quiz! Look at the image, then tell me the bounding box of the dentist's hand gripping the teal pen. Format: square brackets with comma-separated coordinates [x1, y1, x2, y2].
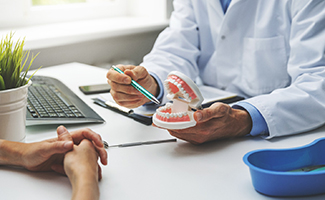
[106, 65, 159, 108]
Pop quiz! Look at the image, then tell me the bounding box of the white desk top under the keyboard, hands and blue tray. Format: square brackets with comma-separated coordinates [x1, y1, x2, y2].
[0, 63, 325, 200]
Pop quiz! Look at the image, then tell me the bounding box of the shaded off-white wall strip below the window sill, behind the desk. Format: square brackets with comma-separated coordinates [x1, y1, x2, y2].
[31, 30, 161, 69]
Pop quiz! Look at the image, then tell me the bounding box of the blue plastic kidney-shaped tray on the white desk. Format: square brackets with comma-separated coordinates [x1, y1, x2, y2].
[243, 138, 325, 196]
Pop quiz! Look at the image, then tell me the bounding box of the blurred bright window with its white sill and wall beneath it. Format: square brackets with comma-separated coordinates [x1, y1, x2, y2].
[0, 0, 173, 69]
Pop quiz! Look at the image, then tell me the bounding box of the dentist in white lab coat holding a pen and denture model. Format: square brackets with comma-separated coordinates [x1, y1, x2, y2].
[107, 0, 325, 144]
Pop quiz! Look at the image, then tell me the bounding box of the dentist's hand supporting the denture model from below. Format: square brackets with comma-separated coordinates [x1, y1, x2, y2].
[168, 103, 252, 144]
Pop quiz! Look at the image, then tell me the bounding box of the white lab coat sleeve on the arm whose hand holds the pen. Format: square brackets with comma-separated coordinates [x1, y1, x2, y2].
[140, 0, 200, 103]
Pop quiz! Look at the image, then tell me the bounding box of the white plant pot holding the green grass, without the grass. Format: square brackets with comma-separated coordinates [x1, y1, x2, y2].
[0, 81, 32, 142]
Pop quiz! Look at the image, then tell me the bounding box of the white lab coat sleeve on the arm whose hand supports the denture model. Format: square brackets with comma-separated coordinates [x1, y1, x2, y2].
[243, 0, 325, 138]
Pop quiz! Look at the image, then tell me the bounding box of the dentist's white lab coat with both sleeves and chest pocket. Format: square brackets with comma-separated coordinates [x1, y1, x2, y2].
[141, 0, 325, 138]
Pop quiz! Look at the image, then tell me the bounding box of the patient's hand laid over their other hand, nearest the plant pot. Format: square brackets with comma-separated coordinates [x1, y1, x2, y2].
[21, 126, 107, 174]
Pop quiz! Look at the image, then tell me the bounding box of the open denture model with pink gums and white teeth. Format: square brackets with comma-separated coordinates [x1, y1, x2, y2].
[153, 71, 203, 129]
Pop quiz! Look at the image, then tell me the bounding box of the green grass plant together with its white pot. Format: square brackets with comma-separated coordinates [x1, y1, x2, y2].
[0, 33, 37, 142]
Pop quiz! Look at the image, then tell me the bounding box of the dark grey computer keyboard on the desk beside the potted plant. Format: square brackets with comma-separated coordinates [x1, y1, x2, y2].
[26, 76, 105, 126]
